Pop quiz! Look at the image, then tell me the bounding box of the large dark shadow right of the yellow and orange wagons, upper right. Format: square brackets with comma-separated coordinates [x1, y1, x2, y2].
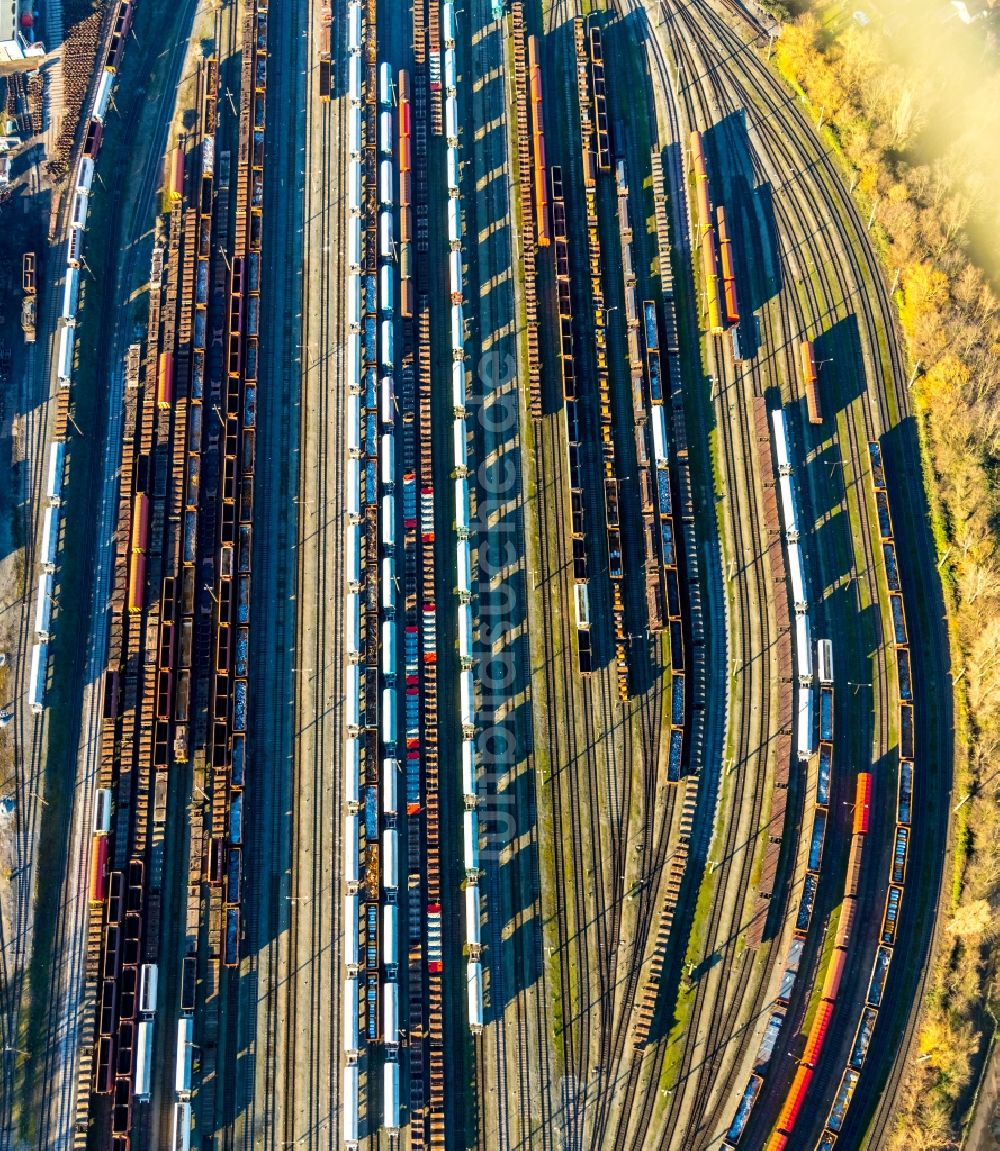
[703, 110, 783, 315]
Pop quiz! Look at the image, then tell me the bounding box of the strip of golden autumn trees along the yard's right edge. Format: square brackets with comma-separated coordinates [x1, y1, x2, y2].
[776, 6, 1000, 1151]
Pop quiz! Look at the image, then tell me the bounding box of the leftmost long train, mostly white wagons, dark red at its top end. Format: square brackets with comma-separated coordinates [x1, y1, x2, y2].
[30, 0, 132, 715]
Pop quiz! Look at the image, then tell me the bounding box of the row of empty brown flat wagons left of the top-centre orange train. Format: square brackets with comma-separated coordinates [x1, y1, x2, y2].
[510, 0, 547, 420]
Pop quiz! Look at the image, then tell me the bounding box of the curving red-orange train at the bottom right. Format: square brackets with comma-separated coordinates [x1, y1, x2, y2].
[759, 771, 871, 1151]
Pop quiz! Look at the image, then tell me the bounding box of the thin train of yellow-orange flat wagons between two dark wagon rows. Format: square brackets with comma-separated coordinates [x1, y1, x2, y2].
[573, 16, 628, 701]
